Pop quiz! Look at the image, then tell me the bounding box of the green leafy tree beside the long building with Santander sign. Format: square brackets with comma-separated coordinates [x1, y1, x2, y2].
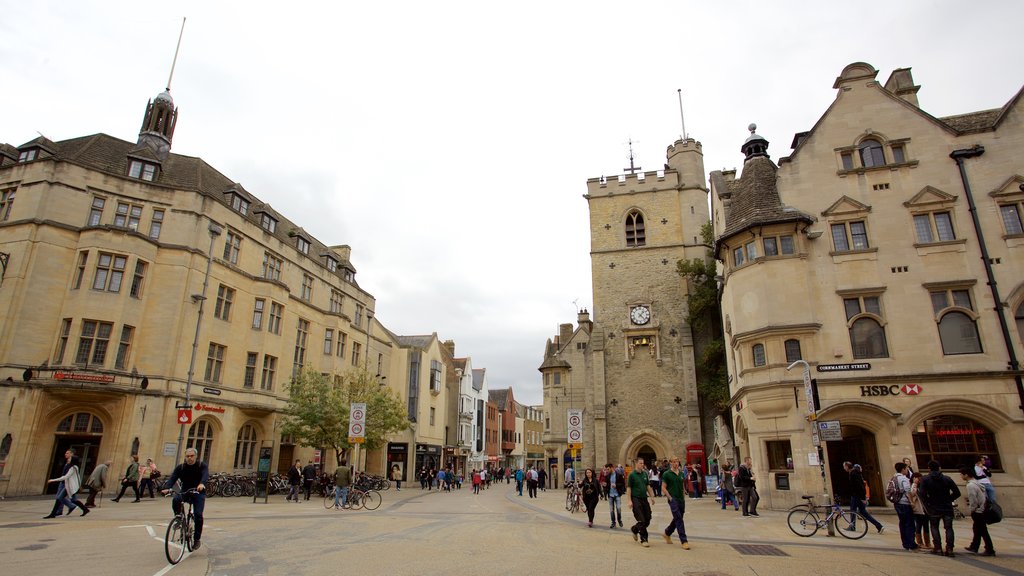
[282, 366, 409, 462]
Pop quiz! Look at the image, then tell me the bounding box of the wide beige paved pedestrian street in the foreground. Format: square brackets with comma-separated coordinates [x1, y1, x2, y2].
[0, 485, 1024, 576]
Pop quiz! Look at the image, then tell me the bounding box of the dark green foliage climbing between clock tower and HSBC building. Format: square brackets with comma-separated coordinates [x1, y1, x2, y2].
[676, 221, 729, 409]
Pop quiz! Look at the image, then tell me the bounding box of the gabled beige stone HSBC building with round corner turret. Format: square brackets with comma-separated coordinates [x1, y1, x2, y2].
[711, 63, 1024, 515]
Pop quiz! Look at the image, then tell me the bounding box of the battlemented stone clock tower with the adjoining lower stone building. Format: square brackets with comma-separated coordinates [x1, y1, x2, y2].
[540, 138, 709, 478]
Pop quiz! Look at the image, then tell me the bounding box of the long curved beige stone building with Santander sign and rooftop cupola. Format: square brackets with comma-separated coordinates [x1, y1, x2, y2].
[0, 85, 385, 495]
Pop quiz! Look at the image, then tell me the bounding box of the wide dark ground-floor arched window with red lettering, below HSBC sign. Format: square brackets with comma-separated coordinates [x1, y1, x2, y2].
[912, 415, 1002, 470]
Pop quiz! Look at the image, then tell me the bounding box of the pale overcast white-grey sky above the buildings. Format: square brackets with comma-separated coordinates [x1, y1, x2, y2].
[0, 0, 1024, 404]
